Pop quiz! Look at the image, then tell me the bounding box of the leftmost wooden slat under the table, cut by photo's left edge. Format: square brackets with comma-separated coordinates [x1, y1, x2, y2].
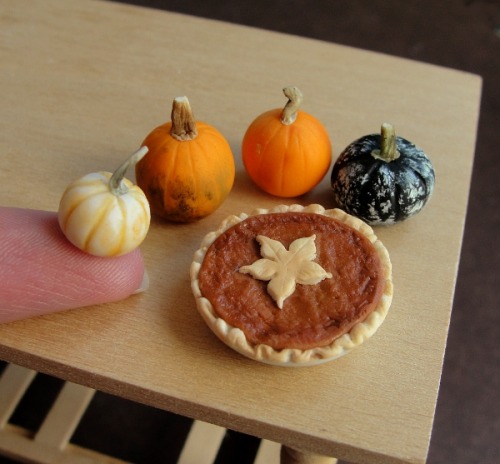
[0, 364, 36, 429]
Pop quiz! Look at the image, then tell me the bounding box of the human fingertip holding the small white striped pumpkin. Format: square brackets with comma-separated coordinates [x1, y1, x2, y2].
[0, 207, 147, 322]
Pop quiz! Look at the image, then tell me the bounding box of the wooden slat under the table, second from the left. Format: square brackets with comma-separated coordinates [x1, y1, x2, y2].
[35, 382, 95, 450]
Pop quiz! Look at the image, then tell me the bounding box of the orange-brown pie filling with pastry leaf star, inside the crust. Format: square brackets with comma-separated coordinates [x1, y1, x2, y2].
[198, 212, 387, 350]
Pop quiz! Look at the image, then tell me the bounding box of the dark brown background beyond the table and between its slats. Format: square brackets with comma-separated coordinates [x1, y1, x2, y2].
[0, 0, 500, 464]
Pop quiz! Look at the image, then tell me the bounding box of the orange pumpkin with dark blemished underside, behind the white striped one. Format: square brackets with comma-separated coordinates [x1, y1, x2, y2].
[135, 97, 235, 222]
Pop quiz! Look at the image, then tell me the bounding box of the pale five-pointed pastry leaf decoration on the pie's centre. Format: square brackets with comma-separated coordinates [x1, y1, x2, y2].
[240, 235, 332, 309]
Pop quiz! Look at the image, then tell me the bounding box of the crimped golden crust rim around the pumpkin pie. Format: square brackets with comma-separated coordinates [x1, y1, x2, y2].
[190, 204, 393, 366]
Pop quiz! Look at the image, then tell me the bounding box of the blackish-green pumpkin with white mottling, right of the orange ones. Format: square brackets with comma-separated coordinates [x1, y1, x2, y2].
[331, 123, 435, 225]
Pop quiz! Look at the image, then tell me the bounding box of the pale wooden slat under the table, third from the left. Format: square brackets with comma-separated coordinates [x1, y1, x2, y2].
[178, 421, 226, 464]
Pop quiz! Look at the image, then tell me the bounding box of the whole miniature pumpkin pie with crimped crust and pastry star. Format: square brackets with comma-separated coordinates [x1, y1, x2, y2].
[191, 205, 392, 366]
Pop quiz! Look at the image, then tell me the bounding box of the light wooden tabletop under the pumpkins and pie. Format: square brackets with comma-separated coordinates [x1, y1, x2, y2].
[0, 0, 481, 464]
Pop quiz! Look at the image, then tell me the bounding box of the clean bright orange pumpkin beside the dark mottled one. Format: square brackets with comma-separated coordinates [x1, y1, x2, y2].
[242, 87, 332, 197]
